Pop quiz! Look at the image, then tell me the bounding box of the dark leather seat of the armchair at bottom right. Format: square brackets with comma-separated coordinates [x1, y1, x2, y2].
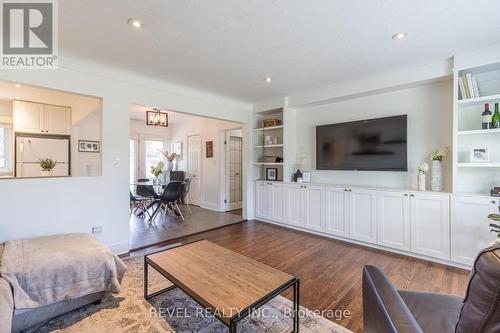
[398, 290, 462, 333]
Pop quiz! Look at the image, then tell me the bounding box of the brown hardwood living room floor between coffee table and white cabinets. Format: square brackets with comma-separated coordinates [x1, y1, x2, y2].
[135, 221, 469, 332]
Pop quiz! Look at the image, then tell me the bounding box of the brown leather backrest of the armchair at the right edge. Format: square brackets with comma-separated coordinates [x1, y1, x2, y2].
[456, 243, 500, 333]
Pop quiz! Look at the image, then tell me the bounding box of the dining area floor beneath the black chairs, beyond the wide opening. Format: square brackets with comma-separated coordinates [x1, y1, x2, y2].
[130, 205, 244, 249]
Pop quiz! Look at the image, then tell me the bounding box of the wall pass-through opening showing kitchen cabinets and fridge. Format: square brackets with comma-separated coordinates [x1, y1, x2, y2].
[0, 81, 102, 179]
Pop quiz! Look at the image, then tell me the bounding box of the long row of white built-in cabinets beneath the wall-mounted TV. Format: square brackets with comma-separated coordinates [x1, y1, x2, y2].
[256, 181, 499, 266]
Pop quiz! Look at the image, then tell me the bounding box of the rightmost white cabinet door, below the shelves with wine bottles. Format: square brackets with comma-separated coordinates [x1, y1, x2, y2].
[451, 196, 498, 265]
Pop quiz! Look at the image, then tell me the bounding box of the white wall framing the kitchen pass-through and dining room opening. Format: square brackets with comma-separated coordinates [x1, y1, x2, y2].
[0, 55, 251, 253]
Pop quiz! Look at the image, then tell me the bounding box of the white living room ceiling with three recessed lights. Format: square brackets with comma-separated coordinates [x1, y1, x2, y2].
[59, 0, 500, 102]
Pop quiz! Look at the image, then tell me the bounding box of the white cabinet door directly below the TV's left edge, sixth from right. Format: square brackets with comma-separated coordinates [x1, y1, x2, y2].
[302, 185, 325, 231]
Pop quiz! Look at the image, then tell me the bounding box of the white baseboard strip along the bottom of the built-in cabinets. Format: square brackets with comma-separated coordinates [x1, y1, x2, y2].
[256, 218, 472, 271]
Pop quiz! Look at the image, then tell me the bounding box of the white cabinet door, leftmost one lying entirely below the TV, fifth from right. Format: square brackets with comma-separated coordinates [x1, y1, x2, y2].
[325, 187, 349, 237]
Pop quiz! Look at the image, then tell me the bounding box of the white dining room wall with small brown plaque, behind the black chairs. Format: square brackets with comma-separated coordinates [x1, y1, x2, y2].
[170, 116, 243, 210]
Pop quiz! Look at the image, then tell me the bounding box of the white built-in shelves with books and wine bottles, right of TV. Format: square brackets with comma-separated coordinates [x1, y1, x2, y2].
[453, 62, 500, 195]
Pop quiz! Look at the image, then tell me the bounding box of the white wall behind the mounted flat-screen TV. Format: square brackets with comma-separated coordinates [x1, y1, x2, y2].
[295, 79, 453, 190]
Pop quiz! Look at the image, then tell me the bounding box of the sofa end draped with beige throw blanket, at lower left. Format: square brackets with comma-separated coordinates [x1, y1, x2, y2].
[0, 234, 125, 333]
